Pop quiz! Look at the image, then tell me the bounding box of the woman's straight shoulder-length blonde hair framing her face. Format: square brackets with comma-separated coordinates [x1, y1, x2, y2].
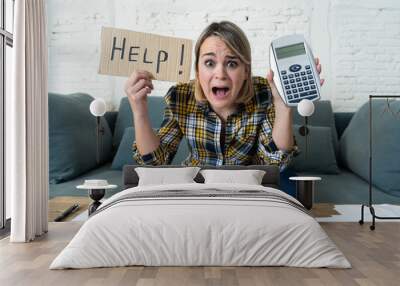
[194, 21, 254, 103]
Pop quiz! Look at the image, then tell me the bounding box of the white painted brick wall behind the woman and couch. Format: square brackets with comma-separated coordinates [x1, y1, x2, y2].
[47, 0, 400, 111]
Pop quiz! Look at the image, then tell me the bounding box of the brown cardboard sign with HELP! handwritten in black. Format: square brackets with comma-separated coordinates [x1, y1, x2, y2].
[99, 27, 192, 82]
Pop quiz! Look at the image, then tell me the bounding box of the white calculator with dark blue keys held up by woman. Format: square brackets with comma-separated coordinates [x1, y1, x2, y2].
[269, 35, 321, 106]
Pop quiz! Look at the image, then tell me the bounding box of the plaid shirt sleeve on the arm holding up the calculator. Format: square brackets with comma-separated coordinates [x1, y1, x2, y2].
[255, 104, 298, 171]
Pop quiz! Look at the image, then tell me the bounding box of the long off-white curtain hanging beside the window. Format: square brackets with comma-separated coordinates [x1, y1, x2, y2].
[6, 0, 48, 242]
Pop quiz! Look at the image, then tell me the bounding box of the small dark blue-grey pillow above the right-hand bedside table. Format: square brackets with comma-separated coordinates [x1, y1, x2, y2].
[292, 125, 340, 174]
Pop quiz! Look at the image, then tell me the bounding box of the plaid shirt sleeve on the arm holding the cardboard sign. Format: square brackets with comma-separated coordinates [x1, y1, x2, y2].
[132, 87, 183, 165]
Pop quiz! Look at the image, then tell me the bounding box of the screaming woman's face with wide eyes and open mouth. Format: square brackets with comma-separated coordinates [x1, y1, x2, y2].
[197, 36, 246, 113]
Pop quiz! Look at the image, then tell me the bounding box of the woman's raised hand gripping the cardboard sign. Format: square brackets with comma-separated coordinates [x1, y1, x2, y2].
[124, 70, 154, 113]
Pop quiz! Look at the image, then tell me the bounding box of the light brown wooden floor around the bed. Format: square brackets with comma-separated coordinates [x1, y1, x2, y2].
[0, 221, 400, 286]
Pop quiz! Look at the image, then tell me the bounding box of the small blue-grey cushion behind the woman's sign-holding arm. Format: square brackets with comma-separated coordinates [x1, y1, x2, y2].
[111, 127, 189, 170]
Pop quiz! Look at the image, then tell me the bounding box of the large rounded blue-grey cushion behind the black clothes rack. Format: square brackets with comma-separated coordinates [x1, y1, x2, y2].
[340, 100, 400, 195]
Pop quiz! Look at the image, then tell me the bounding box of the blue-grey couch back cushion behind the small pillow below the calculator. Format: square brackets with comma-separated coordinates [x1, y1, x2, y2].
[293, 100, 339, 156]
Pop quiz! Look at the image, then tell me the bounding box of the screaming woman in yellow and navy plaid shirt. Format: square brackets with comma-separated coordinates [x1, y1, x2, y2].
[125, 21, 321, 170]
